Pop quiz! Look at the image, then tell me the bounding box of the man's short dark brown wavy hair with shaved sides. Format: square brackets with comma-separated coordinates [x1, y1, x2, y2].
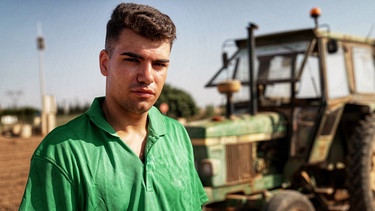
[105, 3, 176, 55]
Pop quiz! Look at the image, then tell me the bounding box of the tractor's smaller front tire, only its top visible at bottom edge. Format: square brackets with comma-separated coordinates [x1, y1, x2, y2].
[264, 190, 315, 211]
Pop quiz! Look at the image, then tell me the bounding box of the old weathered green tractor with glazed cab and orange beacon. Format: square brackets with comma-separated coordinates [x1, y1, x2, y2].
[186, 9, 375, 211]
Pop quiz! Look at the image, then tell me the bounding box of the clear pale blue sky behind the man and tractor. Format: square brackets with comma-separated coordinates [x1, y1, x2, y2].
[0, 0, 375, 108]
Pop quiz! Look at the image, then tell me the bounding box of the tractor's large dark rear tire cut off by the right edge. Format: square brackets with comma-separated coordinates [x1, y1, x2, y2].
[347, 115, 375, 211]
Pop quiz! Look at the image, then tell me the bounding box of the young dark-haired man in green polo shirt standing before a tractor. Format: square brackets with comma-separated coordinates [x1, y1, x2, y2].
[20, 3, 207, 211]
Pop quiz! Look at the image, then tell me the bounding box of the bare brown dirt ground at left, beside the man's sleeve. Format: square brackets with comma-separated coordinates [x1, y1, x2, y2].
[0, 135, 42, 211]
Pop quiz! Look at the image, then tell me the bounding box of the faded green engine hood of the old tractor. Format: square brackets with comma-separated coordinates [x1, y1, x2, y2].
[185, 112, 287, 145]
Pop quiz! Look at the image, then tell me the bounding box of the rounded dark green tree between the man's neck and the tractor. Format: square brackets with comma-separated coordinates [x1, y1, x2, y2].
[155, 84, 198, 118]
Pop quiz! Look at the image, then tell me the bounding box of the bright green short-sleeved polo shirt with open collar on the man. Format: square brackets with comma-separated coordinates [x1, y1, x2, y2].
[20, 98, 207, 211]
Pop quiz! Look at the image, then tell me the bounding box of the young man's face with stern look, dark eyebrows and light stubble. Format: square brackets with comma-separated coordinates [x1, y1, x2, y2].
[100, 29, 171, 114]
